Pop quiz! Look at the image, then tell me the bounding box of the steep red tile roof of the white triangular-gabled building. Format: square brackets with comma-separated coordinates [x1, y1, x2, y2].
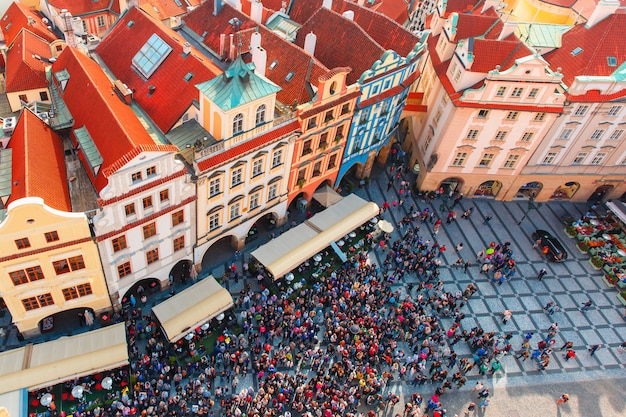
[52, 47, 176, 193]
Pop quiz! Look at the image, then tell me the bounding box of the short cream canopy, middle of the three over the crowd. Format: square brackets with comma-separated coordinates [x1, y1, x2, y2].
[152, 276, 233, 342]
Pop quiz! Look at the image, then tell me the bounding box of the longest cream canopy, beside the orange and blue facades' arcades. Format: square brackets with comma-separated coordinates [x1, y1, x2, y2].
[252, 194, 379, 279]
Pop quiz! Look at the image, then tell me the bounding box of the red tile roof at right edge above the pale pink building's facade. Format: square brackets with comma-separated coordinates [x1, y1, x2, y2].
[543, 11, 626, 85]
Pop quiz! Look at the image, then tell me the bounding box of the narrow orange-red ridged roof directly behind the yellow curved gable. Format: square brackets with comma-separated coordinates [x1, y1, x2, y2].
[8, 109, 72, 212]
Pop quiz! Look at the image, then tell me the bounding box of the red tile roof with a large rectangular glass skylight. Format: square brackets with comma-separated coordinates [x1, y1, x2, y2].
[96, 7, 222, 132]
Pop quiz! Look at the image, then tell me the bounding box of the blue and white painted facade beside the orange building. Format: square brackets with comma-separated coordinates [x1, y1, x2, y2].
[335, 34, 428, 186]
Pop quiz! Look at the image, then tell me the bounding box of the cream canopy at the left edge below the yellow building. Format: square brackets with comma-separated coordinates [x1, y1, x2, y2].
[0, 323, 128, 394]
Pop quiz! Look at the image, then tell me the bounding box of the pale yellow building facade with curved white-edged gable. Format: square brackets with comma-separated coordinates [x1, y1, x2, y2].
[0, 197, 111, 337]
